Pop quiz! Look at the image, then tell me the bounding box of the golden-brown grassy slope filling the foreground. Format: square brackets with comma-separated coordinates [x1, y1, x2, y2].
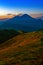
[0, 30, 43, 65]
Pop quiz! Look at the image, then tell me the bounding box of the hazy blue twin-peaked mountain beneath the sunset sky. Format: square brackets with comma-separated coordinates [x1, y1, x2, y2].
[0, 14, 43, 32]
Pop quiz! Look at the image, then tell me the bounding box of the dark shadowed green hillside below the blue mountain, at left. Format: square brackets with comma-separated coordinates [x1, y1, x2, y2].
[0, 29, 19, 43]
